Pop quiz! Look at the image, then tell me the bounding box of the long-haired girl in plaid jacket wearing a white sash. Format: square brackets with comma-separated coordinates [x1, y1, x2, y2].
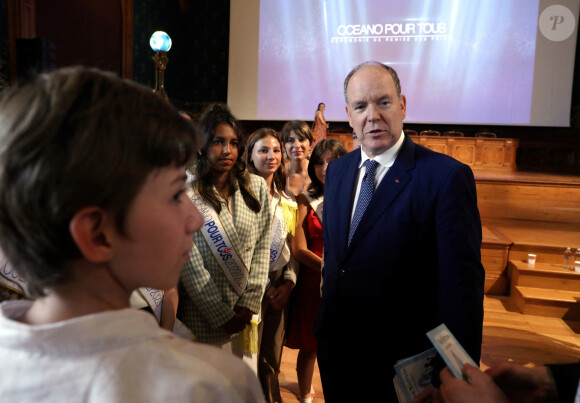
[177, 104, 272, 372]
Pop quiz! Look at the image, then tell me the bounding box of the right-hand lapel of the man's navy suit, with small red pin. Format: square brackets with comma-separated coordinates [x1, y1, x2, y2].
[349, 136, 415, 249]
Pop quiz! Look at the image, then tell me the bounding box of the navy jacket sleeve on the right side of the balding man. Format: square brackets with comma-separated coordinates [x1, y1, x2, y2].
[433, 165, 485, 366]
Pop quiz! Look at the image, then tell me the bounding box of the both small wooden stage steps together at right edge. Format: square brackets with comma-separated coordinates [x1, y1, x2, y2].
[508, 260, 580, 320]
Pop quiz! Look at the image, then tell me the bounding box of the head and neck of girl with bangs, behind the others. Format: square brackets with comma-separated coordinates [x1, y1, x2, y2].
[282, 120, 313, 196]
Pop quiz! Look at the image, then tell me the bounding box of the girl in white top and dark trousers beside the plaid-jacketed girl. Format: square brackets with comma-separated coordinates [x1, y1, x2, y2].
[244, 128, 298, 402]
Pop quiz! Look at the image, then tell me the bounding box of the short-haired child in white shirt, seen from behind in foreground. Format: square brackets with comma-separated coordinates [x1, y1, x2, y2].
[0, 68, 263, 402]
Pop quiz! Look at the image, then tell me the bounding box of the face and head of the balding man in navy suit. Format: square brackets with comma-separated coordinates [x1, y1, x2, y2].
[346, 66, 407, 158]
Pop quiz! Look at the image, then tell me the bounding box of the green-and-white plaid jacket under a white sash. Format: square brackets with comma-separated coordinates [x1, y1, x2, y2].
[178, 175, 272, 343]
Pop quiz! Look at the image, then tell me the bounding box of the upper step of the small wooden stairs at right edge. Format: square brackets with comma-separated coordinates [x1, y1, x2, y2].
[508, 259, 580, 295]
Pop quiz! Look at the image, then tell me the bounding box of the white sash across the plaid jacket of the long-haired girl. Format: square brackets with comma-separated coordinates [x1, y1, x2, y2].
[191, 190, 249, 295]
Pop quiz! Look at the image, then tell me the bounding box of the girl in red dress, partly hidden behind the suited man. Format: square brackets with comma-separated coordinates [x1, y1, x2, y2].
[286, 140, 347, 402]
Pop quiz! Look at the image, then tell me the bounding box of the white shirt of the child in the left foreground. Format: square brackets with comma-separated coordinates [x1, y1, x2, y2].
[0, 300, 264, 403]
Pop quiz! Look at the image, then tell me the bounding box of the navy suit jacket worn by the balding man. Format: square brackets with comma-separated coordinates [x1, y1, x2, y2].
[314, 137, 484, 382]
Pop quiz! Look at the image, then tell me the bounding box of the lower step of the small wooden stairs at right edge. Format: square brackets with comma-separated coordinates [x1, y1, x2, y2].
[510, 285, 580, 320]
